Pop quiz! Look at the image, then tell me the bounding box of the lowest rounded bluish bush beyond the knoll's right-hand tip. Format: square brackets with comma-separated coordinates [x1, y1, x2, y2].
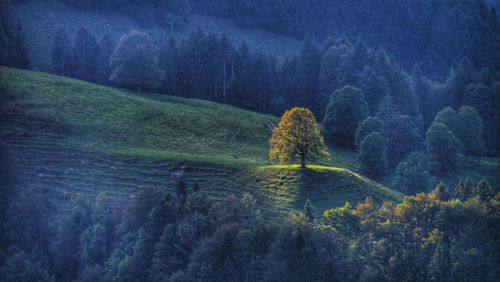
[394, 152, 433, 195]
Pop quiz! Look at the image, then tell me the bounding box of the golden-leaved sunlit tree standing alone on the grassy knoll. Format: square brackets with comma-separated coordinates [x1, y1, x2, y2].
[269, 108, 329, 168]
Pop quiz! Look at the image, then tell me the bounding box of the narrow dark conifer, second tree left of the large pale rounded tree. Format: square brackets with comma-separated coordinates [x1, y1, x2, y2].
[51, 27, 71, 76]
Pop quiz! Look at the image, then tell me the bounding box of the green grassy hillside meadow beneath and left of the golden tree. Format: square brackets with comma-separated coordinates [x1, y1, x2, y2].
[0, 68, 401, 218]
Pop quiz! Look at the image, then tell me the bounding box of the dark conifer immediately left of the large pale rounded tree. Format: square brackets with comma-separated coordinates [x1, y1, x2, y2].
[71, 27, 99, 82]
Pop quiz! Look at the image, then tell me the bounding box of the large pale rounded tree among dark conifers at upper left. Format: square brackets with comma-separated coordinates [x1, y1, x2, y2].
[109, 31, 165, 91]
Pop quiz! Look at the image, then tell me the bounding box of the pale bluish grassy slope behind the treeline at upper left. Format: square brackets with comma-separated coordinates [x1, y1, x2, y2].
[8, 1, 301, 71]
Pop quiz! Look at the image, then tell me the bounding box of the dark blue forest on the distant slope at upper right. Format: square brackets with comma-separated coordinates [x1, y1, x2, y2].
[192, 0, 500, 77]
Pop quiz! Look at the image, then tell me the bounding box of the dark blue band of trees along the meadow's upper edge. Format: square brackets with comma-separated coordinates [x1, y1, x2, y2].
[4, 19, 500, 160]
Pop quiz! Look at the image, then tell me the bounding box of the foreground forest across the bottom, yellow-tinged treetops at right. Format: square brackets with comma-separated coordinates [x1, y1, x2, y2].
[0, 178, 500, 282]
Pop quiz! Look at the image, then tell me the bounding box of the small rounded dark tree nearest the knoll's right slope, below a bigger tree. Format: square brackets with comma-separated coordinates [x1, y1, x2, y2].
[358, 132, 387, 177]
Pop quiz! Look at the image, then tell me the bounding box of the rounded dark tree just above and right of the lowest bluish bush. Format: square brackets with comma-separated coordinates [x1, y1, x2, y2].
[425, 122, 461, 173]
